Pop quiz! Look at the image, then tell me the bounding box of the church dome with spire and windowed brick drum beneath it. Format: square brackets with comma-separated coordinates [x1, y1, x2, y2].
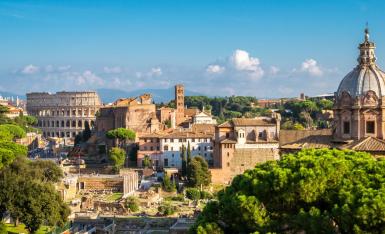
[333, 29, 385, 140]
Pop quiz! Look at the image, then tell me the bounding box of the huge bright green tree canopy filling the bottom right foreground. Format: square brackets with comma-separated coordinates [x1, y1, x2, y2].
[193, 149, 385, 233]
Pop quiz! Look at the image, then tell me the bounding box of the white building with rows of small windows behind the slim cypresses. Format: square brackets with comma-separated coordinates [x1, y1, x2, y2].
[160, 131, 213, 168]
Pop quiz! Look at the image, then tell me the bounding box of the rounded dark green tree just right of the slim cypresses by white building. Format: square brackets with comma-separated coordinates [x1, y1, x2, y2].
[187, 156, 211, 187]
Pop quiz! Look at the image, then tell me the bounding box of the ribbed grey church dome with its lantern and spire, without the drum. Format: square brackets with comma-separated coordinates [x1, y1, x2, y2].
[336, 29, 385, 99]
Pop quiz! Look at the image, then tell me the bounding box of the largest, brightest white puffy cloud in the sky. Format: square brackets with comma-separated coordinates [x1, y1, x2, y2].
[230, 49, 264, 79]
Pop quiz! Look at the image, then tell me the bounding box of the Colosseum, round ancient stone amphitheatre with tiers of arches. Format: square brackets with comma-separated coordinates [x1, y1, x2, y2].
[27, 91, 102, 138]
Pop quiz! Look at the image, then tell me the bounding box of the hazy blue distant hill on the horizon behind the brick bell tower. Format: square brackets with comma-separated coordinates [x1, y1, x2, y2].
[96, 87, 203, 103]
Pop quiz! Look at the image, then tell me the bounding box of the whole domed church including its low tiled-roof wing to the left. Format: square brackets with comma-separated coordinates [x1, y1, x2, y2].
[280, 29, 385, 157]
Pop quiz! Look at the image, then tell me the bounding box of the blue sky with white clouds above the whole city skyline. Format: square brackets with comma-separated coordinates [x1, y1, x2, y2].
[0, 0, 385, 97]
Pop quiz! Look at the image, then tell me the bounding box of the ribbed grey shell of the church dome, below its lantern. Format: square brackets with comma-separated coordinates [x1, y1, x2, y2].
[337, 65, 385, 98]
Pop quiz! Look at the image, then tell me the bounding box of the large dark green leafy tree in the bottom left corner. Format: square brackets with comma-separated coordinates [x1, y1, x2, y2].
[0, 157, 70, 233]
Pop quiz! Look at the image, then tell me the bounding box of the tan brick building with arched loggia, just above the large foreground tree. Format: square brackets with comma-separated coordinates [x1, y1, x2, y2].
[211, 113, 281, 183]
